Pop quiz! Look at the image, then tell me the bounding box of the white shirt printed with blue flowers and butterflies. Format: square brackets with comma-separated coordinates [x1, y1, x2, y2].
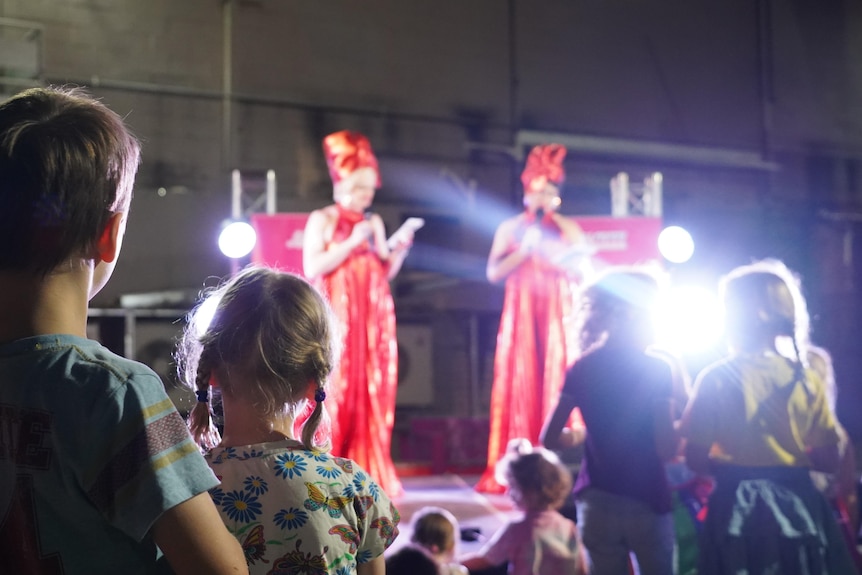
[207, 440, 400, 575]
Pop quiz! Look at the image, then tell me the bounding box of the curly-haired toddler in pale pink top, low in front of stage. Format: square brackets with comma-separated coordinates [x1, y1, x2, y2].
[461, 439, 586, 575]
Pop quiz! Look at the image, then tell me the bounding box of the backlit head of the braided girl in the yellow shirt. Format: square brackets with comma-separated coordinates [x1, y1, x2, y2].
[719, 260, 808, 356]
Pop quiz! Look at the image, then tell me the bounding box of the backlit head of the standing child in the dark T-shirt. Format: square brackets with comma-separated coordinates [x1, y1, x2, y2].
[576, 267, 660, 352]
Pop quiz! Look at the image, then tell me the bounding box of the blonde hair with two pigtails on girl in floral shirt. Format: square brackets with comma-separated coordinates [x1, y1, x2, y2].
[177, 267, 340, 448]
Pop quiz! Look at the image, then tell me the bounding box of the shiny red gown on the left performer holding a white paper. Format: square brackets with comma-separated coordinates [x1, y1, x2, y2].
[317, 206, 402, 497]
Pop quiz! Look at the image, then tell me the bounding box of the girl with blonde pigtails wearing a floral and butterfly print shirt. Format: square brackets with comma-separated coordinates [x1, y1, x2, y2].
[177, 267, 399, 575]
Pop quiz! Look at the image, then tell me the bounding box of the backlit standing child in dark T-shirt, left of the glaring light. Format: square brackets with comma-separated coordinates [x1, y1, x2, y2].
[542, 267, 678, 575]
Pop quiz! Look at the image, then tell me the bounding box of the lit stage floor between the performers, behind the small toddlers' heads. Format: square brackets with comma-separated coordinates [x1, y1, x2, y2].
[387, 474, 519, 555]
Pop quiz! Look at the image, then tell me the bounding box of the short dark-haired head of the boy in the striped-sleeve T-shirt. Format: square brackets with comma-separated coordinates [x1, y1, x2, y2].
[0, 88, 140, 280]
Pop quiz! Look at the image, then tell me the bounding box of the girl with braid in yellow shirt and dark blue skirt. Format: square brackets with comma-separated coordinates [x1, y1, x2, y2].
[682, 261, 856, 575]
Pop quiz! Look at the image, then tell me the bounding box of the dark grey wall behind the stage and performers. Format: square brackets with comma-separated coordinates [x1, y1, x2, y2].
[0, 0, 862, 463]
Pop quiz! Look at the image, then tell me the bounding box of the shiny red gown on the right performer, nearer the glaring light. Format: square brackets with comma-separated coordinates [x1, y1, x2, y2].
[476, 215, 575, 493]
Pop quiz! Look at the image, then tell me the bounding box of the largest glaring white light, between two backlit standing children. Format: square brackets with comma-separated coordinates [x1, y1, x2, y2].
[655, 285, 723, 354]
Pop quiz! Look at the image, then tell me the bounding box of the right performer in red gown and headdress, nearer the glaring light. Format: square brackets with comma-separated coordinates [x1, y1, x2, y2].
[476, 144, 589, 493]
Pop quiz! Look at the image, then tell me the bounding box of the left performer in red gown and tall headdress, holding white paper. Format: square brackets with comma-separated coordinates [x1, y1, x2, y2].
[302, 131, 413, 497]
